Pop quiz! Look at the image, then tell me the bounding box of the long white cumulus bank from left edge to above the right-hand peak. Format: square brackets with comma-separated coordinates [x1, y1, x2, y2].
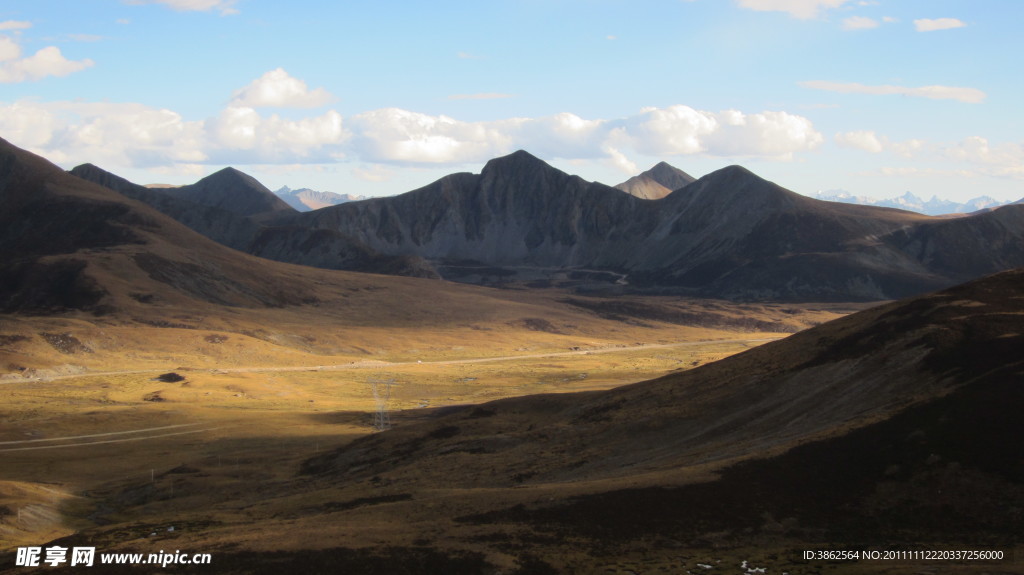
[0, 71, 822, 171]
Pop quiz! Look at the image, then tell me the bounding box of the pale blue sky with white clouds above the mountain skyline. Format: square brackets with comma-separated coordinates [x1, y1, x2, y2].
[0, 0, 1024, 201]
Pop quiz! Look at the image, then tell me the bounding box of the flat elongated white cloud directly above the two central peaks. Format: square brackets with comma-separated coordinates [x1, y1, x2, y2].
[346, 105, 822, 165]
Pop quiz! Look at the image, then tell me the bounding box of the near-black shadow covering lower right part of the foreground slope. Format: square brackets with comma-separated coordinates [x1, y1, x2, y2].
[461, 366, 1024, 545]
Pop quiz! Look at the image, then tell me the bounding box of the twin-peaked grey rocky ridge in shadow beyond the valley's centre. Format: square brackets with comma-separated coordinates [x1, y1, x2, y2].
[272, 151, 1021, 299]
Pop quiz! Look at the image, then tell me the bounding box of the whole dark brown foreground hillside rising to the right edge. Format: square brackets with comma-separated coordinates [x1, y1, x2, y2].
[286, 270, 1024, 573]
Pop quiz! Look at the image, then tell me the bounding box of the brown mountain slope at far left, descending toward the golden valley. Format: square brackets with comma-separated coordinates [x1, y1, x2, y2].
[0, 136, 331, 314]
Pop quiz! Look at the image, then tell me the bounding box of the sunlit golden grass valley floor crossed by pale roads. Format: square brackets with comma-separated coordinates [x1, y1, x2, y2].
[0, 278, 847, 549]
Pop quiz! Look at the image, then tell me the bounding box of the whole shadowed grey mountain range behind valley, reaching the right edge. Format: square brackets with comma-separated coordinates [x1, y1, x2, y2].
[61, 150, 1024, 301]
